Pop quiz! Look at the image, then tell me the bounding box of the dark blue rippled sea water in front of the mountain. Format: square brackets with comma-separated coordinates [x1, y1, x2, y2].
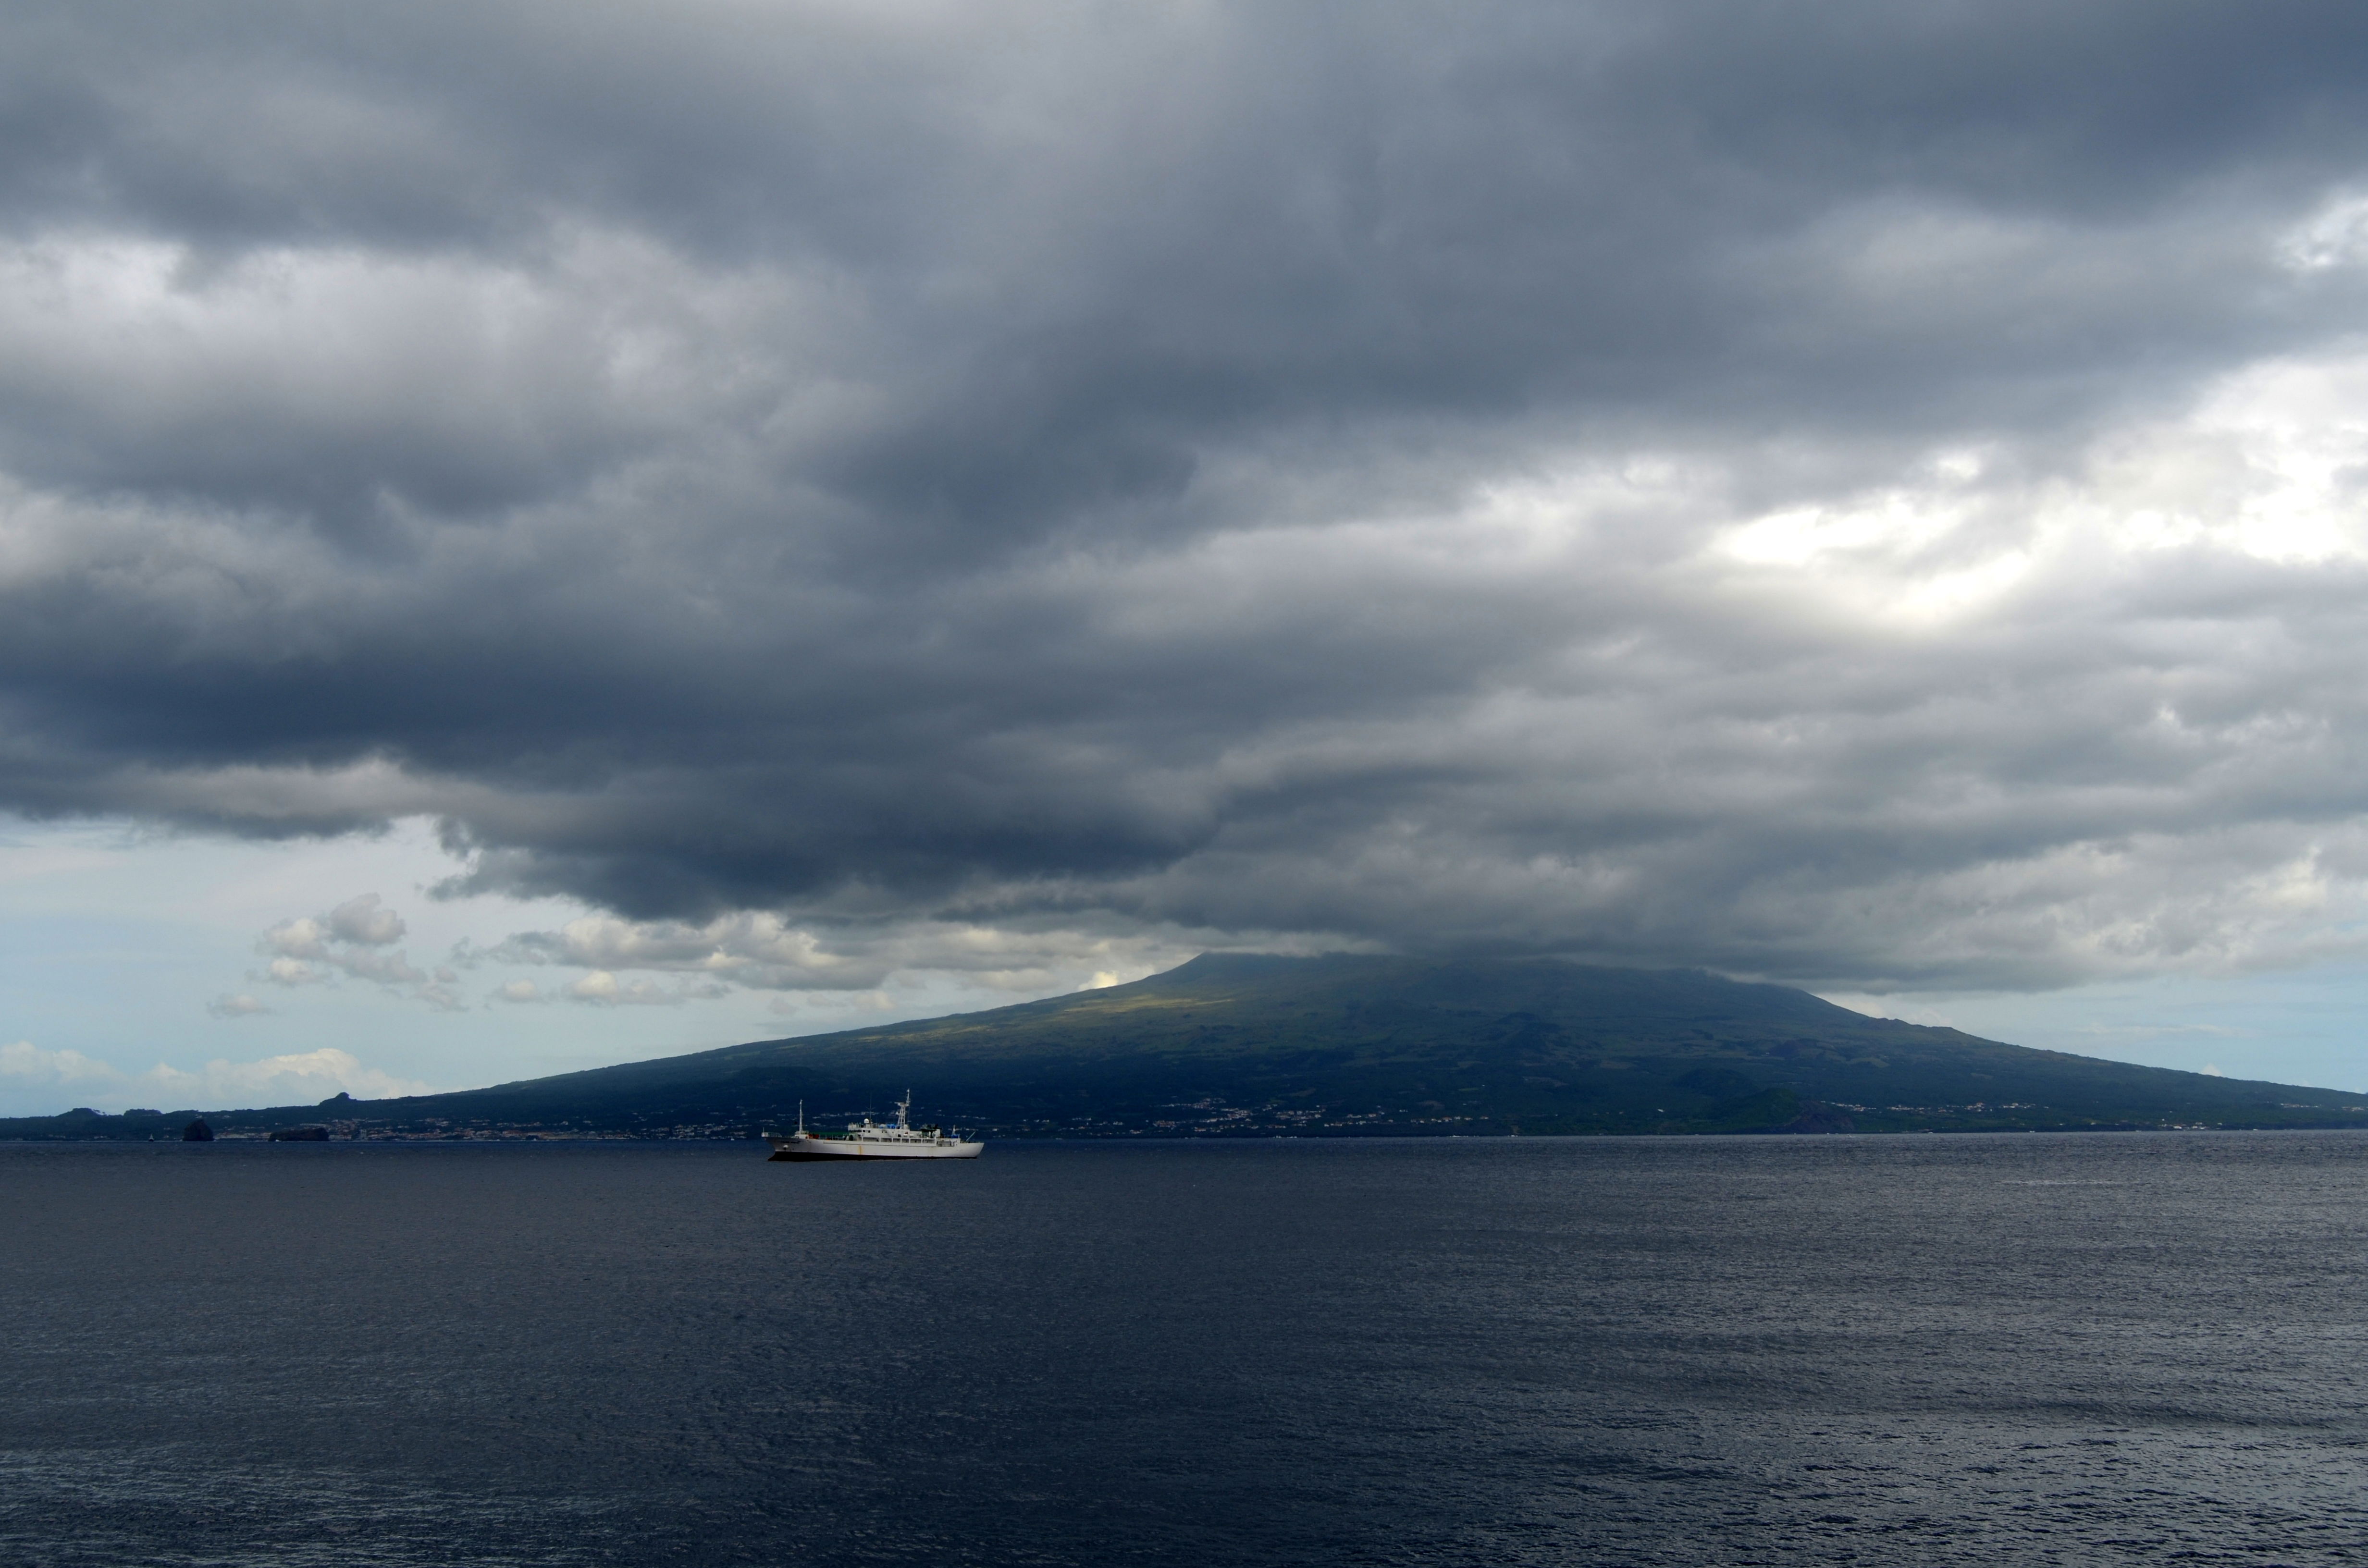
[0, 1135, 2368, 1568]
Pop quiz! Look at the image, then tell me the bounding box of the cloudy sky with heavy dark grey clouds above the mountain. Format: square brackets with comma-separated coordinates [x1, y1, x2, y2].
[0, 0, 2368, 1113]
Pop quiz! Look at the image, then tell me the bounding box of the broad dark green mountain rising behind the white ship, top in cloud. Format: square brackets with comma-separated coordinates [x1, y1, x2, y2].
[23, 955, 2368, 1137]
